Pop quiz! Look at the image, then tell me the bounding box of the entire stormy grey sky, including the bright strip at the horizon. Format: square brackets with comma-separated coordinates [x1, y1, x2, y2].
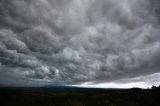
[0, 0, 160, 88]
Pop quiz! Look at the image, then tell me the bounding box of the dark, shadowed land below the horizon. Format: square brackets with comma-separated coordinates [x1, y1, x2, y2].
[0, 87, 160, 106]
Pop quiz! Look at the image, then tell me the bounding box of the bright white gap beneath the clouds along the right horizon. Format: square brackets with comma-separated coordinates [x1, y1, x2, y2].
[70, 73, 160, 89]
